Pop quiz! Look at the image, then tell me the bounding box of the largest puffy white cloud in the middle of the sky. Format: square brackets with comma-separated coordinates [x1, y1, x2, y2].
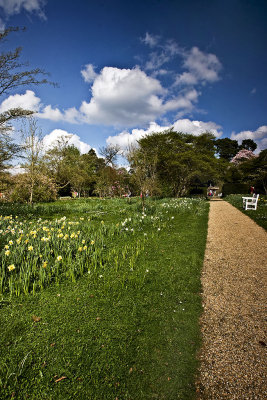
[80, 67, 170, 126]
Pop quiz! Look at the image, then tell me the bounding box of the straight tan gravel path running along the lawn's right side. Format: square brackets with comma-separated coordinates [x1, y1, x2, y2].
[197, 201, 267, 400]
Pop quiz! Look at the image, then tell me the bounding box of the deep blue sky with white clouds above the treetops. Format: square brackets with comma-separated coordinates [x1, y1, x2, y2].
[0, 0, 267, 152]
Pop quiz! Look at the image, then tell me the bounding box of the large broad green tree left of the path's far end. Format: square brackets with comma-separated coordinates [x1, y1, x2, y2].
[128, 130, 220, 196]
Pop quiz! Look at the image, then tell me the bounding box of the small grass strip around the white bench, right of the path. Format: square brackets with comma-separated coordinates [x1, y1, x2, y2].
[224, 194, 267, 230]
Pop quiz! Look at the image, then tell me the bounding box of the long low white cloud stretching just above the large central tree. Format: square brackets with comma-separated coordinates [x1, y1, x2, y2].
[106, 119, 222, 150]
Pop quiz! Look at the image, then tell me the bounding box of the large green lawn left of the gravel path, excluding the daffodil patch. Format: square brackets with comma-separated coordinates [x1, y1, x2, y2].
[0, 199, 208, 400]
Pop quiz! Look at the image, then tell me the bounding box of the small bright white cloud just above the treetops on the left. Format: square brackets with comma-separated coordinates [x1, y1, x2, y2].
[43, 129, 92, 154]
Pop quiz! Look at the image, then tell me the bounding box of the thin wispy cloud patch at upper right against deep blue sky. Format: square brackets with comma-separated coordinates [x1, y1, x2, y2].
[175, 47, 222, 85]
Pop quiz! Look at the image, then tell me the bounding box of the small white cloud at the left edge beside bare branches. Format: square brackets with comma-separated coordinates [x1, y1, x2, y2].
[0, 90, 41, 113]
